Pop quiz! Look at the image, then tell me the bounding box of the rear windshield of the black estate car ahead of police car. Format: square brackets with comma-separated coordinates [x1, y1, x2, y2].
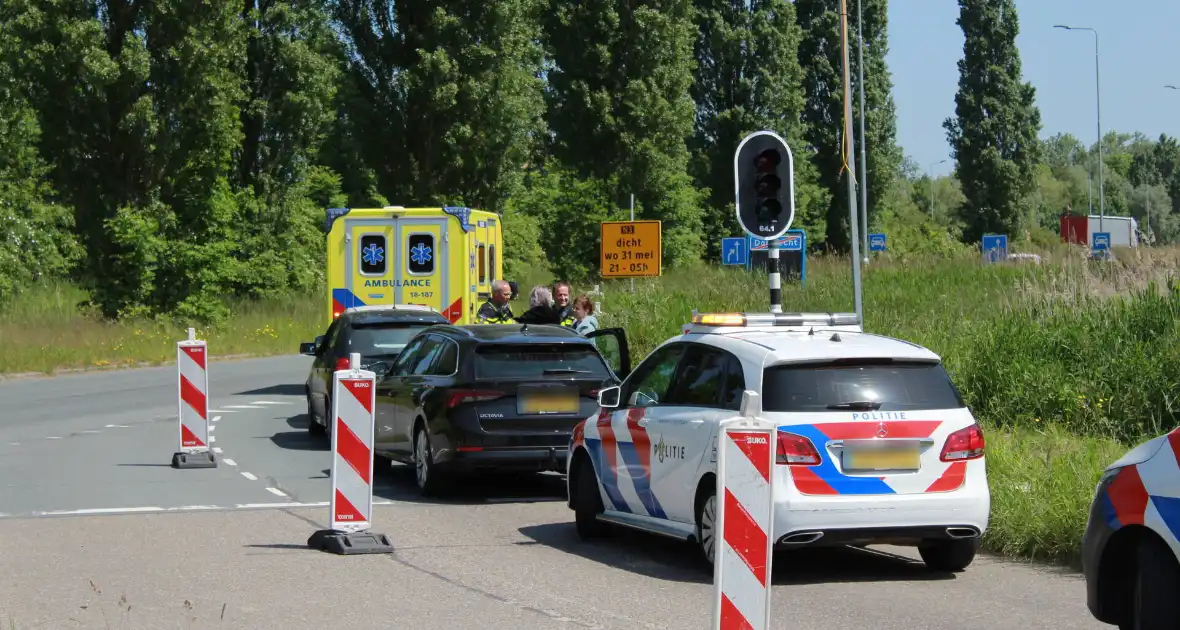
[476, 343, 610, 380]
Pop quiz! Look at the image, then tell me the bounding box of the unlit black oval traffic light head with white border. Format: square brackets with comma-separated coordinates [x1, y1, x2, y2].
[734, 131, 795, 239]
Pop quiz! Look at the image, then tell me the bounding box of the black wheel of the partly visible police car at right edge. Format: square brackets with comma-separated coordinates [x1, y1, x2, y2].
[1120, 536, 1180, 630]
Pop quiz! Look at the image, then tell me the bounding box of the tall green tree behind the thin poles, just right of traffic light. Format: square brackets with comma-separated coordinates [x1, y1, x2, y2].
[794, 0, 902, 251]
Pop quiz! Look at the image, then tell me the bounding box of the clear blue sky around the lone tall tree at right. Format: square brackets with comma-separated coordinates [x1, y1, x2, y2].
[887, 0, 1180, 175]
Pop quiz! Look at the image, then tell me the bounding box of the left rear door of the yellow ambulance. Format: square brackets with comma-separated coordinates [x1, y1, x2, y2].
[342, 216, 399, 308]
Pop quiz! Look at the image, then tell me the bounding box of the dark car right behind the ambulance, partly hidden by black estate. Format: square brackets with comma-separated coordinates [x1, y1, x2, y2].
[299, 304, 451, 435]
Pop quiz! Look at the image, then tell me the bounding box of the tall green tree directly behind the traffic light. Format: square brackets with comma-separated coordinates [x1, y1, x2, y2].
[689, 0, 826, 260]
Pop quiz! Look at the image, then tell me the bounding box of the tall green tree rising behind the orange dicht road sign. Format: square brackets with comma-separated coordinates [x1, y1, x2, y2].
[544, 0, 703, 265]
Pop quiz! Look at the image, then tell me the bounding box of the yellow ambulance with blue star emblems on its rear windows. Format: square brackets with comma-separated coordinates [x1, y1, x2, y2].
[323, 205, 504, 324]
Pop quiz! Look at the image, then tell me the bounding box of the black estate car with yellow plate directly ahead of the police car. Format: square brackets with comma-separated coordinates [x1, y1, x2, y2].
[374, 324, 630, 494]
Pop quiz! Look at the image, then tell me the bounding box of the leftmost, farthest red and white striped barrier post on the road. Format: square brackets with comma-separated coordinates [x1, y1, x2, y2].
[172, 328, 217, 468]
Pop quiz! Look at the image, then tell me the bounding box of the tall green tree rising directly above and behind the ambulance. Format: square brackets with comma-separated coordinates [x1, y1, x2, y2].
[332, 0, 544, 210]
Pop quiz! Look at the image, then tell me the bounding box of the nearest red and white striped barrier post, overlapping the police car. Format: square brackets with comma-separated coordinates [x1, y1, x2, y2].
[713, 391, 778, 630]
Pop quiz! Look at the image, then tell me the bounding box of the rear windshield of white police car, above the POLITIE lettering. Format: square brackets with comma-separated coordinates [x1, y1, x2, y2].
[762, 361, 964, 412]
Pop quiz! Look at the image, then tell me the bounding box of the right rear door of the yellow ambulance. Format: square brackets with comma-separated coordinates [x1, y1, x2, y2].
[395, 217, 450, 322]
